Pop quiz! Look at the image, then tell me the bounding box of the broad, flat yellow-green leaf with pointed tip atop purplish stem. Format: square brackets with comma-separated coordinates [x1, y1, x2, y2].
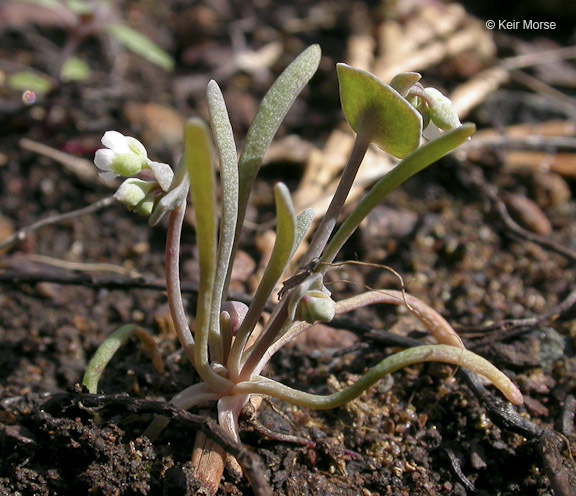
[337, 64, 422, 158]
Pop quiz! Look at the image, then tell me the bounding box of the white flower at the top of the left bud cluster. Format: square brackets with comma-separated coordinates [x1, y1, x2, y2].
[94, 131, 148, 179]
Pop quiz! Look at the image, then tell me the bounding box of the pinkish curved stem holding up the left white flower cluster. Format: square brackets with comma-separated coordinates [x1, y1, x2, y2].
[166, 201, 194, 365]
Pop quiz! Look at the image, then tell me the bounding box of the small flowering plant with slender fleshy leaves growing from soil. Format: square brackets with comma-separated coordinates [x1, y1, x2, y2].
[84, 46, 522, 482]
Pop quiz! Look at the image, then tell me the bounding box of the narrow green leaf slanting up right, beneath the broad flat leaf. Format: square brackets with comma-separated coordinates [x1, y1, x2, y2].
[321, 123, 476, 263]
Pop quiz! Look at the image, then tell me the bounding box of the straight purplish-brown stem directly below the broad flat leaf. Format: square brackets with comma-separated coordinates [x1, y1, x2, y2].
[300, 129, 371, 267]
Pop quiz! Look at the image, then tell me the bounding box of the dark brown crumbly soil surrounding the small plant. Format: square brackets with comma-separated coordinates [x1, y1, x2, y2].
[0, 0, 576, 496]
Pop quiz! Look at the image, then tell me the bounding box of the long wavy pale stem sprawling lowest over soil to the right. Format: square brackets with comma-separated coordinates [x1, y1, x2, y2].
[232, 344, 523, 410]
